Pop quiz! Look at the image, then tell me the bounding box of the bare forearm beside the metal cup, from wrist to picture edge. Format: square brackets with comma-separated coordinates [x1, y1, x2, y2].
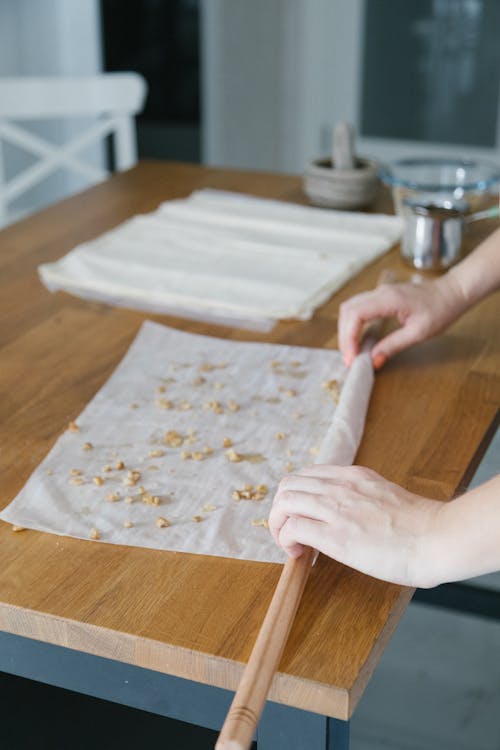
[448, 229, 500, 311]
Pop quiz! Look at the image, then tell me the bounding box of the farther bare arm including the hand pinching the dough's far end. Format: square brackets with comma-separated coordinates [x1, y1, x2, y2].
[339, 229, 500, 368]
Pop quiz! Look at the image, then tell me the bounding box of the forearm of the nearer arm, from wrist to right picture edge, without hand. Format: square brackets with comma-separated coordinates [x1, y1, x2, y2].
[425, 474, 500, 586]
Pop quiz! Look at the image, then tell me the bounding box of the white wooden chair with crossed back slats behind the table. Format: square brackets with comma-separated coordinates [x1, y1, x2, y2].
[0, 73, 147, 226]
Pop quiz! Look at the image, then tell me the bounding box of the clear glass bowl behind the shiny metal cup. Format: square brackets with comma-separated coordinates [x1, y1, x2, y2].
[379, 158, 500, 215]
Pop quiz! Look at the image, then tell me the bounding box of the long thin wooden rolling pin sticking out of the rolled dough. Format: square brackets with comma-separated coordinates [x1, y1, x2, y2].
[215, 271, 394, 750]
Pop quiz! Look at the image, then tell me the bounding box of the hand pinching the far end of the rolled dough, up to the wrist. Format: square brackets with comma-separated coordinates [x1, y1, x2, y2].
[338, 274, 467, 369]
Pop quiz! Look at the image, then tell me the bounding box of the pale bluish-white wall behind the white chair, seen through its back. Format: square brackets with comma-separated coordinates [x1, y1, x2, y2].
[0, 0, 104, 220]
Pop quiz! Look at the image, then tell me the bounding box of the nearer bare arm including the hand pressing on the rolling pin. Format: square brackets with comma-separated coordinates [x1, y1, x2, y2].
[269, 465, 500, 588]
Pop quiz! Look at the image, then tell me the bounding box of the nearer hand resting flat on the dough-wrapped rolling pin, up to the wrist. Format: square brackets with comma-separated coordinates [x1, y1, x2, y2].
[269, 464, 443, 588]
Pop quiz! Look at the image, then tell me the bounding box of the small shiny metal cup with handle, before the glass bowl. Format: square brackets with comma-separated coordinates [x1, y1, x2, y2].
[401, 199, 499, 271]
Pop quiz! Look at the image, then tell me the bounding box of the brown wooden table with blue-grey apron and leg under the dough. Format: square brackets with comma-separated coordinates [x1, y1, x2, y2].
[0, 162, 500, 750]
